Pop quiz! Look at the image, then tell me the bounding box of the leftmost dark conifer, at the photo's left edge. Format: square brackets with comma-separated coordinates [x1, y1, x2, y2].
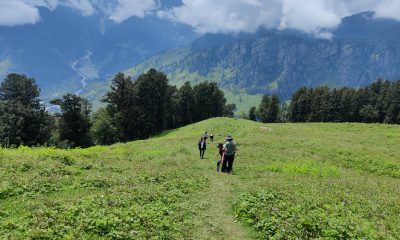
[0, 73, 54, 146]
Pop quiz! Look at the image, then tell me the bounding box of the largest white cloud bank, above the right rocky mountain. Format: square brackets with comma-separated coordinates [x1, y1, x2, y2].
[158, 0, 400, 38]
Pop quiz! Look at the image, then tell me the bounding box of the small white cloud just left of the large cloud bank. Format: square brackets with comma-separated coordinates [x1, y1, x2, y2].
[109, 0, 159, 23]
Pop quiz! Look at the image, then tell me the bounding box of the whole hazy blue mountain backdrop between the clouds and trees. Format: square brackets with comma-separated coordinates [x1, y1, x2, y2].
[0, 0, 400, 109]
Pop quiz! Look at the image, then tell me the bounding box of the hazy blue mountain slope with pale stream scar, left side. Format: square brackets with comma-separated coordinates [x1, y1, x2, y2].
[0, 3, 197, 100]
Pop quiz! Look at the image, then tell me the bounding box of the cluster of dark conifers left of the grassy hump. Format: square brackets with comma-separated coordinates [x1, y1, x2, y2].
[0, 69, 235, 148]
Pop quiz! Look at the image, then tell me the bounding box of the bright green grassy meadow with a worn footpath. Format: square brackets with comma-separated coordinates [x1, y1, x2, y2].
[0, 118, 400, 239]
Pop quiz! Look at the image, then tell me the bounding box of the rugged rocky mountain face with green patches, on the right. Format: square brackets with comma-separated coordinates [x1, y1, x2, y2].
[129, 13, 400, 99]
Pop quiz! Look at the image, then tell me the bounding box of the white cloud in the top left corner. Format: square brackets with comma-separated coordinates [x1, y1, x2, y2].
[0, 0, 40, 26]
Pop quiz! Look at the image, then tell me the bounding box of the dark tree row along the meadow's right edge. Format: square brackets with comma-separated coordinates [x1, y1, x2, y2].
[244, 80, 400, 124]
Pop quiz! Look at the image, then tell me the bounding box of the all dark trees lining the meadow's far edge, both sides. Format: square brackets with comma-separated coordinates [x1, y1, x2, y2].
[0, 69, 400, 148]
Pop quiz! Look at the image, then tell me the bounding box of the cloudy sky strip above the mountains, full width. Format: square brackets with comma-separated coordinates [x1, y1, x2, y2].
[0, 0, 400, 38]
